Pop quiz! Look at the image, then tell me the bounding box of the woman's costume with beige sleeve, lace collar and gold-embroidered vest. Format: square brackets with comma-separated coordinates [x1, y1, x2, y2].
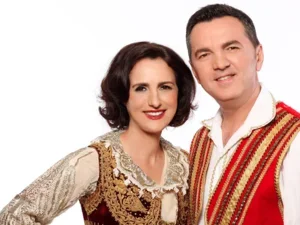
[0, 131, 189, 225]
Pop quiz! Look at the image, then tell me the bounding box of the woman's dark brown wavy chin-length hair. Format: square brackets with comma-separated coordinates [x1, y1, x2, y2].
[99, 42, 196, 129]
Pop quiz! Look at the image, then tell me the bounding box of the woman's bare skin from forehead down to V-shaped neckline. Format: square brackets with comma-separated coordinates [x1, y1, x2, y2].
[121, 58, 178, 183]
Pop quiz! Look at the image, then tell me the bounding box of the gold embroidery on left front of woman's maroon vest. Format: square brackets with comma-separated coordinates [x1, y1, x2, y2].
[97, 143, 161, 224]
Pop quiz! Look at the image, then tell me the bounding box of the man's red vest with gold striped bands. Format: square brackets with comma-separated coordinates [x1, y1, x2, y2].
[189, 103, 300, 225]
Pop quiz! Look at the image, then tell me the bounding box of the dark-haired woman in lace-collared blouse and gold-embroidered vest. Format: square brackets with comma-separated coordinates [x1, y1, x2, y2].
[0, 42, 195, 225]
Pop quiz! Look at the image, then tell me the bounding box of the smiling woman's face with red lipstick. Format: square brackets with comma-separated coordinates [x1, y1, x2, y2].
[126, 58, 178, 134]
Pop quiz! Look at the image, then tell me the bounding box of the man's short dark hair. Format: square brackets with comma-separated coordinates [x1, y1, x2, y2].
[186, 4, 259, 58]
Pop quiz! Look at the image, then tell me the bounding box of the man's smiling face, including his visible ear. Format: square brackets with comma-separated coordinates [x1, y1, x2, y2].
[190, 16, 263, 104]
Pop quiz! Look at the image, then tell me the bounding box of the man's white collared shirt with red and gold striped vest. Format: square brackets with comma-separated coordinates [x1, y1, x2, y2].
[189, 87, 300, 225]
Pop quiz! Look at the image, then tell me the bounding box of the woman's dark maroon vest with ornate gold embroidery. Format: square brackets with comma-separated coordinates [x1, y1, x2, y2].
[80, 142, 188, 225]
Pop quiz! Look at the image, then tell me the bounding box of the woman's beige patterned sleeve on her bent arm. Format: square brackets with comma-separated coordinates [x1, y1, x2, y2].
[0, 148, 99, 225]
